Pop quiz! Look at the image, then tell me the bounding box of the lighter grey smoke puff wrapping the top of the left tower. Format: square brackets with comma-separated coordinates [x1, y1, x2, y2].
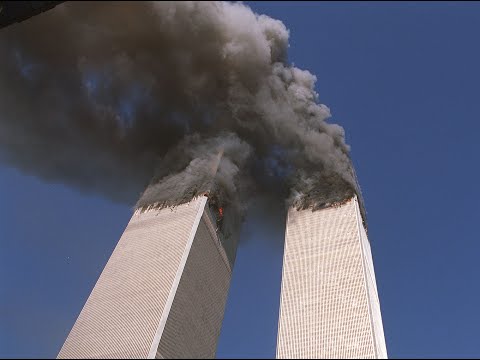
[136, 133, 251, 209]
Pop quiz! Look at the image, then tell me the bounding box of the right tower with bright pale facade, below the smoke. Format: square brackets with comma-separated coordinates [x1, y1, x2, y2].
[277, 196, 387, 359]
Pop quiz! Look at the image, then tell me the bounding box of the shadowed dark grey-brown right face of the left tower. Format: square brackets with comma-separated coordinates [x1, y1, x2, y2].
[156, 204, 232, 359]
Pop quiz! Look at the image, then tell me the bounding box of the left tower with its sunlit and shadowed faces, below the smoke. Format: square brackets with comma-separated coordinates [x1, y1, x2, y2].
[58, 196, 236, 359]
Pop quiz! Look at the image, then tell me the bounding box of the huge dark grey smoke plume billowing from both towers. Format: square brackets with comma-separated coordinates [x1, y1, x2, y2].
[0, 2, 355, 211]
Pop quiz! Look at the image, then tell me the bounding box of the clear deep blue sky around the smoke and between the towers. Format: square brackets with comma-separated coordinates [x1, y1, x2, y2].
[0, 2, 480, 358]
